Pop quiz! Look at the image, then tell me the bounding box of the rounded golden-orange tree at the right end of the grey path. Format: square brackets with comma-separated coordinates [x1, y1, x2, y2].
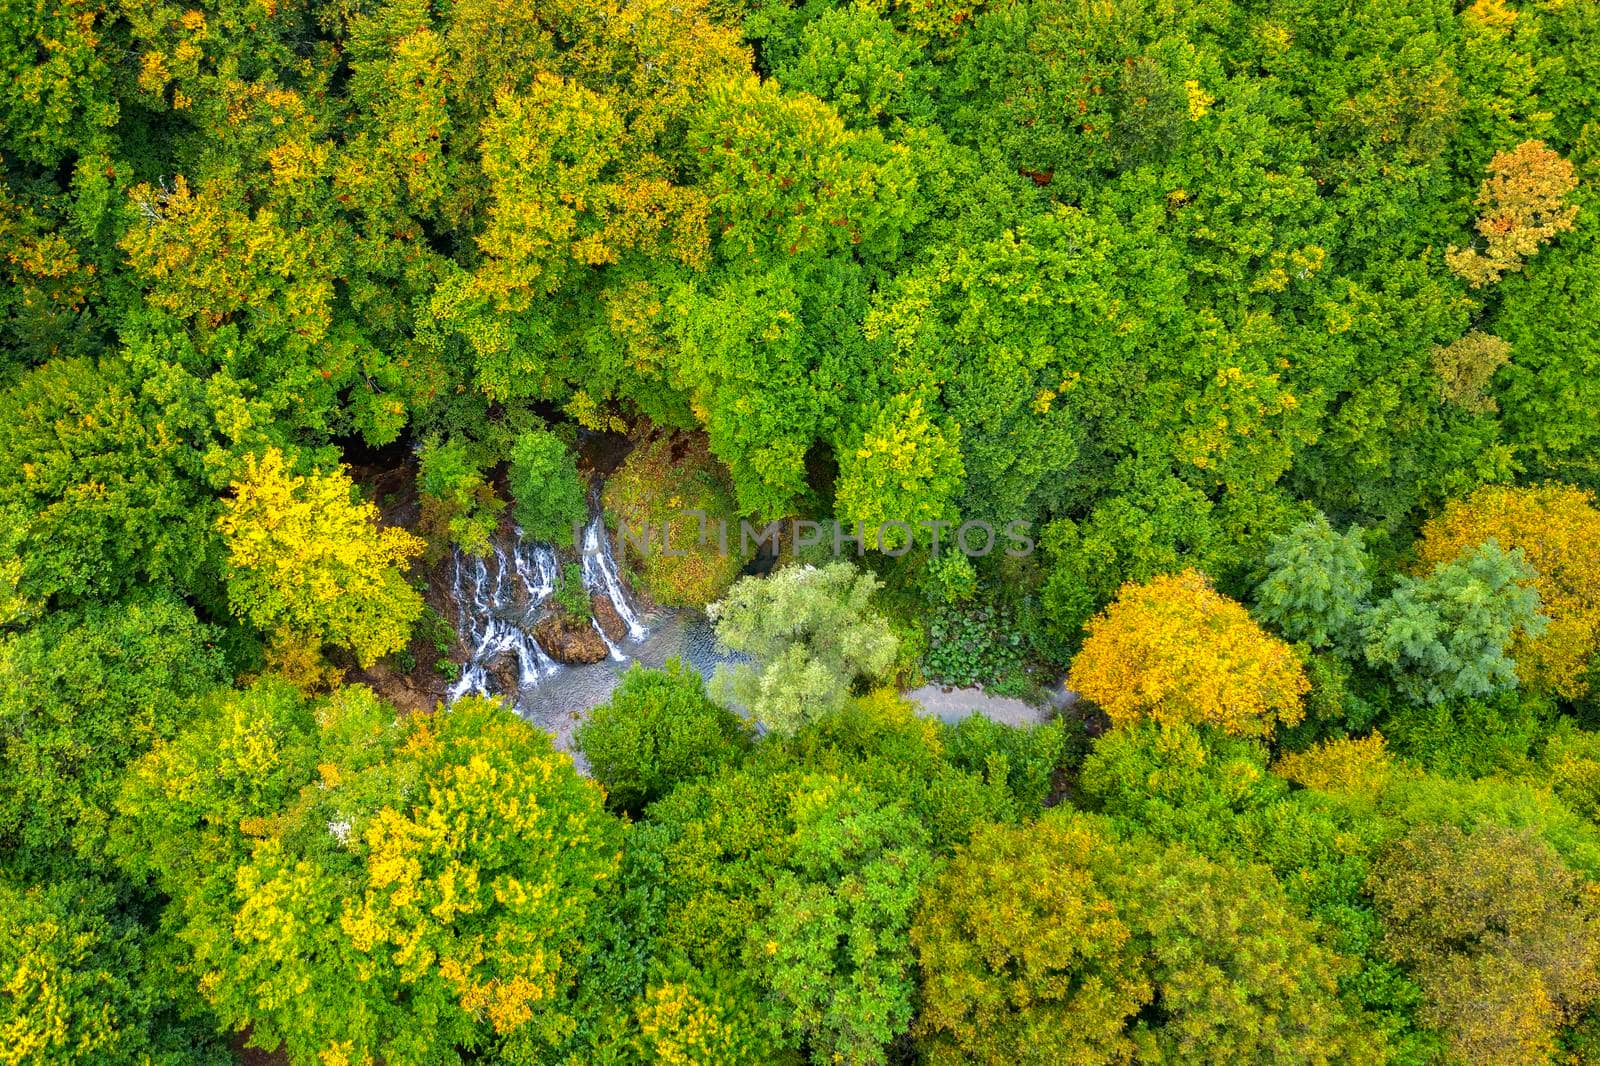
[1067, 570, 1310, 736]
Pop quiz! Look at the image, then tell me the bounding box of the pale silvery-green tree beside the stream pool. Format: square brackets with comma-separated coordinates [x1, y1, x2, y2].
[707, 562, 898, 733]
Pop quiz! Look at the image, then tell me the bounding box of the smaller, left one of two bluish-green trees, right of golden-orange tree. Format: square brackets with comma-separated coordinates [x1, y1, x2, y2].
[1256, 512, 1373, 648]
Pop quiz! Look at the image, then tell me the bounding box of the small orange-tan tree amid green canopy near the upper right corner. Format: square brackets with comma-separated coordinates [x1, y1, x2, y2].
[1445, 141, 1578, 288]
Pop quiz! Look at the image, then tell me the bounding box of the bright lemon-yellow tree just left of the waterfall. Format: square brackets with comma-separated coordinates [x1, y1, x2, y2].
[218, 448, 422, 666]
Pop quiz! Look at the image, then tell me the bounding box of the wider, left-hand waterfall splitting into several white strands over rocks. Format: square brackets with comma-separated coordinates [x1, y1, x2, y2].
[448, 530, 560, 703]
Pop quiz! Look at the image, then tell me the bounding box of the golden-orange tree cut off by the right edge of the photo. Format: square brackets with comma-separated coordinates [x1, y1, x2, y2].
[1418, 483, 1600, 698]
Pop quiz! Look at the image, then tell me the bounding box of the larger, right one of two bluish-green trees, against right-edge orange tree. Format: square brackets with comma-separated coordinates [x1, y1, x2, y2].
[1362, 539, 1546, 703]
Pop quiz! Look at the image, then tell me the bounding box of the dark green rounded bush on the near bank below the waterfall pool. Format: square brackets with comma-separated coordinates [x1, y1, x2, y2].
[576, 659, 749, 812]
